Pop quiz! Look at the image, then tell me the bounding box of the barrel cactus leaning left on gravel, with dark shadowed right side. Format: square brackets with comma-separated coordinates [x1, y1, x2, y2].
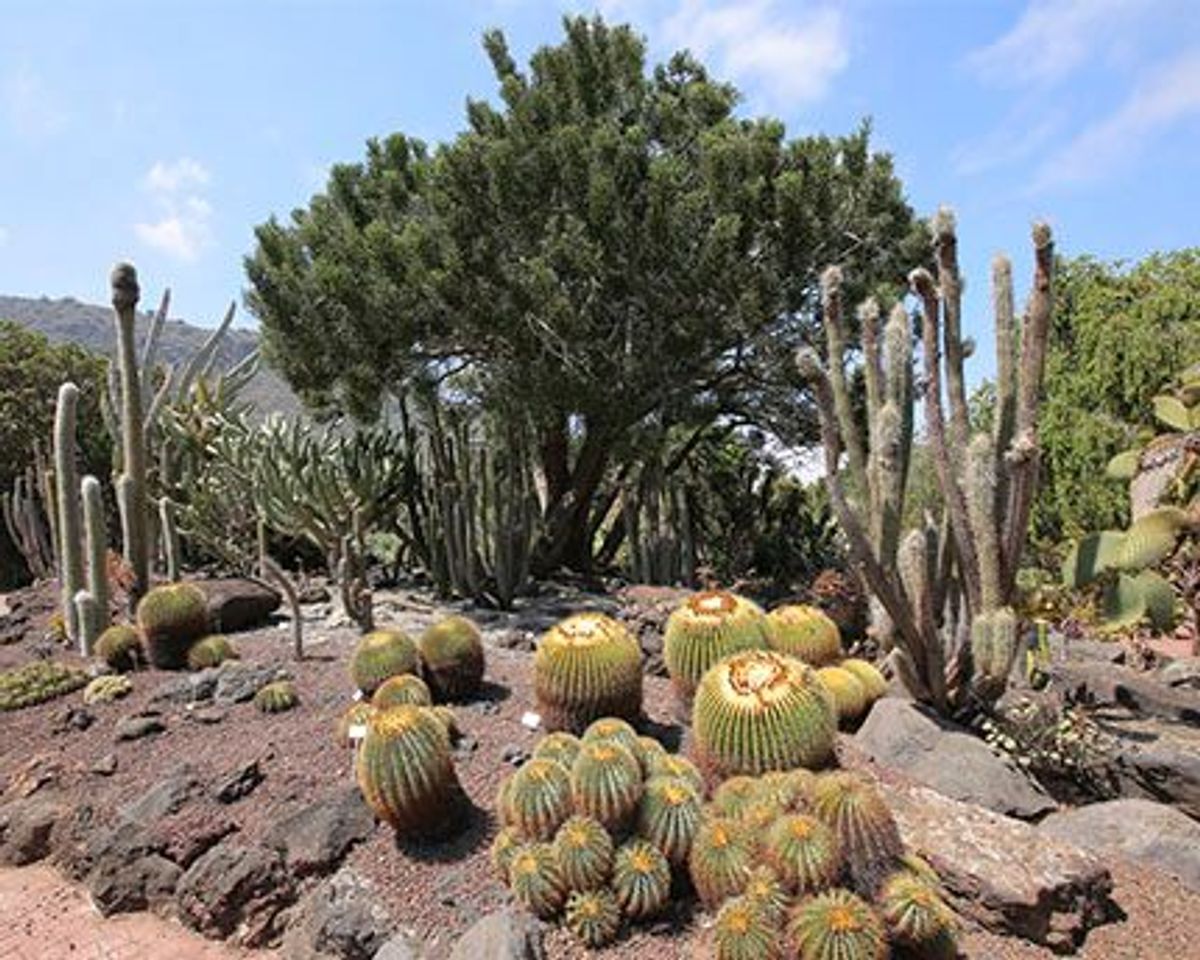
[355, 707, 463, 835]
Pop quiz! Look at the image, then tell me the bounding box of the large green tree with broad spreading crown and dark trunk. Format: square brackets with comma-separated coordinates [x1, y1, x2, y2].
[247, 18, 923, 569]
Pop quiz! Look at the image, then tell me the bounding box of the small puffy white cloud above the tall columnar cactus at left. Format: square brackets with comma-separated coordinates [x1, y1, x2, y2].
[133, 157, 212, 260]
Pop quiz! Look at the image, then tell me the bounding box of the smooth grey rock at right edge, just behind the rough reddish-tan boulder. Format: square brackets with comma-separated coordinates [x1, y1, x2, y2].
[1038, 800, 1200, 890]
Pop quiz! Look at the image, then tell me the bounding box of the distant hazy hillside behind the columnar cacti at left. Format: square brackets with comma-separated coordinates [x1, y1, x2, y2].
[0, 296, 300, 415]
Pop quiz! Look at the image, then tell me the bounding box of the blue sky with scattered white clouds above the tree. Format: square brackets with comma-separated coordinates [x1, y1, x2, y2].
[0, 0, 1200, 384]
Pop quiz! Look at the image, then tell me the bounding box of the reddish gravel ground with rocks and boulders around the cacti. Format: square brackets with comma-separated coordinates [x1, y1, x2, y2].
[0, 578, 1200, 960]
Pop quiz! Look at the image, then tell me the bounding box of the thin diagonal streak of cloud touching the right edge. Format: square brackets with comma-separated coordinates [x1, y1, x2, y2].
[1037, 48, 1200, 187]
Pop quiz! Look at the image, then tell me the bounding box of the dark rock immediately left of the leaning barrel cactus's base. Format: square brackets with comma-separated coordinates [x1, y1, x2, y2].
[264, 787, 374, 877]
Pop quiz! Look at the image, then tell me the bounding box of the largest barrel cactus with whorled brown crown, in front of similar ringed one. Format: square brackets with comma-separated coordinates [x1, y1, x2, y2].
[692, 650, 838, 776]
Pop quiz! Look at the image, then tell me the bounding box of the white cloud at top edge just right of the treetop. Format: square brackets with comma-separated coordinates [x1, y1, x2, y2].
[662, 0, 850, 107]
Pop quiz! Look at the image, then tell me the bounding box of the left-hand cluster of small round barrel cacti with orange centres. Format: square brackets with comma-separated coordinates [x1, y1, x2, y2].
[492, 718, 703, 948]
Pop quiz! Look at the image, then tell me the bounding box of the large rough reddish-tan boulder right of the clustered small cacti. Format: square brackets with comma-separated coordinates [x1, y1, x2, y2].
[887, 785, 1114, 952]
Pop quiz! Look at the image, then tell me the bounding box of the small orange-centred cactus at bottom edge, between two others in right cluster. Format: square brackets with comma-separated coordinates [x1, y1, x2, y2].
[787, 889, 888, 960]
